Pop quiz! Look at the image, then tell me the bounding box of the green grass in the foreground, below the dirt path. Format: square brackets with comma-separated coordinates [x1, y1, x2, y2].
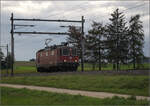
[1, 87, 149, 106]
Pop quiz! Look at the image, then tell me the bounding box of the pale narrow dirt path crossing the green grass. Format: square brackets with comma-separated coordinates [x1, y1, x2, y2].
[0, 84, 150, 100]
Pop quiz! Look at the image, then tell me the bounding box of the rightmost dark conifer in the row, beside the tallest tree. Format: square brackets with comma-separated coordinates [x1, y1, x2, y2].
[129, 15, 144, 69]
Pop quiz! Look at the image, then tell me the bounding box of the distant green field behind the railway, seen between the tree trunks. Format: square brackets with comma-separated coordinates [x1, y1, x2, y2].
[2, 61, 150, 74]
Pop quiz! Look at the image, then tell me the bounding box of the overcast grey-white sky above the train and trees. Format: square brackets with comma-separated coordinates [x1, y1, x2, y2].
[0, 1, 150, 61]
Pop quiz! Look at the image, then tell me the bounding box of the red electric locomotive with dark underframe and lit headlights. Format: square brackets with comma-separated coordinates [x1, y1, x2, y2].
[36, 45, 79, 72]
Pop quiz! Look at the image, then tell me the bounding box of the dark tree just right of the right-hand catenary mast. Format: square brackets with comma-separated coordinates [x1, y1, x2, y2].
[86, 21, 105, 70]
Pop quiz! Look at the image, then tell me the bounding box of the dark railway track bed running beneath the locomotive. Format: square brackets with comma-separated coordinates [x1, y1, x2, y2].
[1, 70, 150, 77]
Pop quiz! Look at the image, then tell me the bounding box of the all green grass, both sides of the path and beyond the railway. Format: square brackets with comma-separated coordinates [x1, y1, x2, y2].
[1, 61, 150, 106]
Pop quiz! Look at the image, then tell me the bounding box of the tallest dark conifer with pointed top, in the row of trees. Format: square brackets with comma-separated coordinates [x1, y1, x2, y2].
[107, 9, 128, 70]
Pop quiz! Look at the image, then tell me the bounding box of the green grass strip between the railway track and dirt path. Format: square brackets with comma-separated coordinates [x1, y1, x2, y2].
[1, 74, 149, 96]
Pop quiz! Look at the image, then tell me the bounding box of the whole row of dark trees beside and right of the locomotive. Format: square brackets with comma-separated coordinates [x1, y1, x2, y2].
[67, 9, 144, 70]
